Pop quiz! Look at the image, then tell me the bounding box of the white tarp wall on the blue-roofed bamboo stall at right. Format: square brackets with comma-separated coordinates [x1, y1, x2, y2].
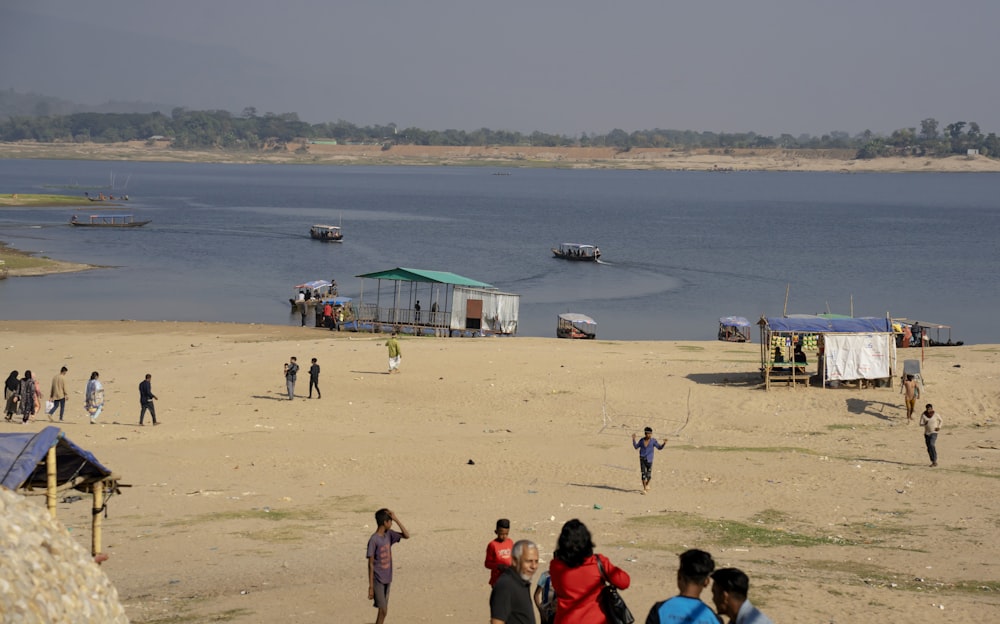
[823, 333, 896, 381]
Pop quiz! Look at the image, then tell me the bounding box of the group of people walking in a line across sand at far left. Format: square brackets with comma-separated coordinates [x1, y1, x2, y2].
[4, 366, 159, 425]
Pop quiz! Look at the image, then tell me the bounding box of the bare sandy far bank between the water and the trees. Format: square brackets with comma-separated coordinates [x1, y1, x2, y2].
[0, 141, 1000, 173]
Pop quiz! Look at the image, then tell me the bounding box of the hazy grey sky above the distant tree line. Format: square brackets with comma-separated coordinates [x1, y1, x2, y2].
[0, 0, 1000, 135]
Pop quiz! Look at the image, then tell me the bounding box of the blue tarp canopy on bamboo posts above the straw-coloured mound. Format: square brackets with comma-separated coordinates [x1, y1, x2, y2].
[0, 427, 111, 490]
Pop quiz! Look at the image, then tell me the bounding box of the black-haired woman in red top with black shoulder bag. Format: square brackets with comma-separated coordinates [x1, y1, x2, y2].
[549, 518, 631, 624]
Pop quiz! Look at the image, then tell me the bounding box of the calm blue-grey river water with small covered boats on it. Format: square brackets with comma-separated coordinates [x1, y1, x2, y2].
[0, 160, 1000, 343]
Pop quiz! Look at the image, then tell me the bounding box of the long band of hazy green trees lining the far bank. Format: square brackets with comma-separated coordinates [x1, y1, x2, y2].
[0, 102, 1000, 158]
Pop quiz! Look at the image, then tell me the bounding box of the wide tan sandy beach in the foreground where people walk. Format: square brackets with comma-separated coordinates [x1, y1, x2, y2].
[0, 321, 1000, 624]
